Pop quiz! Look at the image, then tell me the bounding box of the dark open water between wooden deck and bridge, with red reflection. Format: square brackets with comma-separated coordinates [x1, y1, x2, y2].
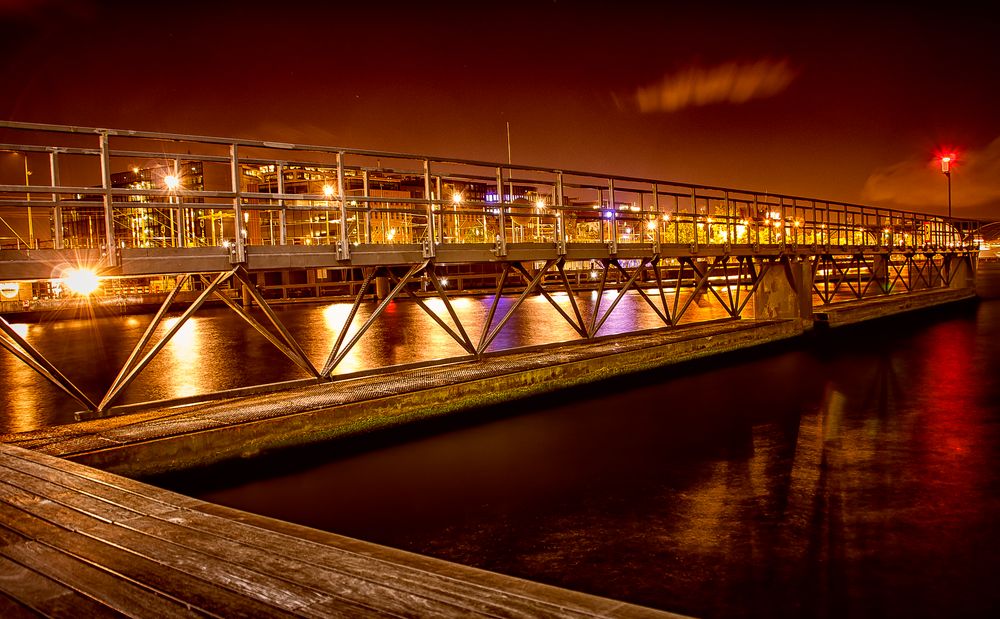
[159, 272, 1000, 617]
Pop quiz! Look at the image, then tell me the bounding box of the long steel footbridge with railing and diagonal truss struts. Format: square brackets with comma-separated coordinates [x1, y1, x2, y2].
[0, 122, 980, 414]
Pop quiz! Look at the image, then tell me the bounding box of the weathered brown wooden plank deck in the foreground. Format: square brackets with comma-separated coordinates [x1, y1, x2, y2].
[0, 444, 677, 617]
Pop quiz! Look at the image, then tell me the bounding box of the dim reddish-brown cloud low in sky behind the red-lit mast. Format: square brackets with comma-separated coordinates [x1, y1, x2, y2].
[862, 137, 1000, 219]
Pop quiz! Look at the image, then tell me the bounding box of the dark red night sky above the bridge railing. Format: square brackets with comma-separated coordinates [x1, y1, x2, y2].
[0, 0, 1000, 219]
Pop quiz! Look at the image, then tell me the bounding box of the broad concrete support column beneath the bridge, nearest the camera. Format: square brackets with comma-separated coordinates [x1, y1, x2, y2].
[753, 259, 813, 325]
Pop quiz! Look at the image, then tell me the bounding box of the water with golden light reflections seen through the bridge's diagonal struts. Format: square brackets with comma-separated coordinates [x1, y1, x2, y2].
[0, 291, 736, 434]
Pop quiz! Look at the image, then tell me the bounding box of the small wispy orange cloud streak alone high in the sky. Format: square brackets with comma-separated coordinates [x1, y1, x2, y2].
[633, 58, 797, 113]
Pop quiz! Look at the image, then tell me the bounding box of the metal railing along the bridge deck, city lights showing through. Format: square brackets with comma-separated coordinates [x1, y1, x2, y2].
[0, 121, 978, 266]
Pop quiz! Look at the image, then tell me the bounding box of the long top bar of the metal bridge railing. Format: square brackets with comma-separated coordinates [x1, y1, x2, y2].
[0, 120, 978, 221]
